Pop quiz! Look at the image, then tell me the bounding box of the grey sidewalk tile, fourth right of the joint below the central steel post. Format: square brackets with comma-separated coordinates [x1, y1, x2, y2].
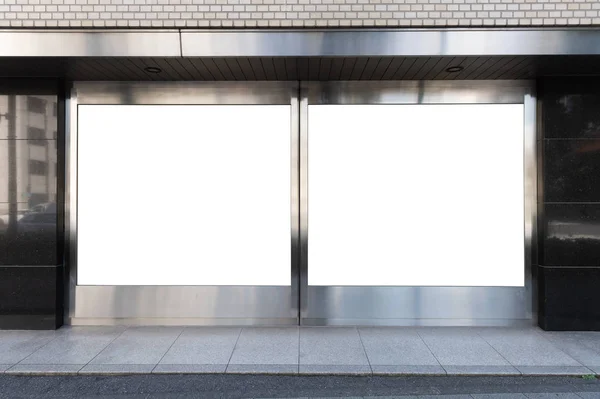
[479, 328, 581, 366]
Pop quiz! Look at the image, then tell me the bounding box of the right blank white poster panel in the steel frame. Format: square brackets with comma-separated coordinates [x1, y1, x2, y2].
[308, 104, 525, 286]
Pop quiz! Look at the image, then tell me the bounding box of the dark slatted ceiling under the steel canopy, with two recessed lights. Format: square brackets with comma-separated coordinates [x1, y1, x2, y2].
[0, 56, 600, 81]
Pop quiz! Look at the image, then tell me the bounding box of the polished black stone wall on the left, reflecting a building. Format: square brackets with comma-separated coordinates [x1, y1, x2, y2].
[0, 80, 64, 329]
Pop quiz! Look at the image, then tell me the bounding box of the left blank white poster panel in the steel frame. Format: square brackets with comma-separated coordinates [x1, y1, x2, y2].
[77, 105, 291, 286]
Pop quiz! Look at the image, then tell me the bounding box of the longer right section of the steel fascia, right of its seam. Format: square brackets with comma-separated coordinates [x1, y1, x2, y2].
[181, 29, 600, 57]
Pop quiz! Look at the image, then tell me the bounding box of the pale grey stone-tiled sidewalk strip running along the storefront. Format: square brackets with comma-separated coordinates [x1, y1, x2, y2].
[0, 327, 600, 376]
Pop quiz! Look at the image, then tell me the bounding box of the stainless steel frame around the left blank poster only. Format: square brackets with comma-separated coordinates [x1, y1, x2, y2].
[65, 82, 299, 325]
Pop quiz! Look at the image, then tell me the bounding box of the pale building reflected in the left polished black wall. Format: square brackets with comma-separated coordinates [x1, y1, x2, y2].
[0, 95, 57, 214]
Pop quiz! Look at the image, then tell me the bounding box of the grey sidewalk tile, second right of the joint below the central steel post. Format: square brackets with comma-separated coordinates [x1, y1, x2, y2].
[359, 328, 440, 366]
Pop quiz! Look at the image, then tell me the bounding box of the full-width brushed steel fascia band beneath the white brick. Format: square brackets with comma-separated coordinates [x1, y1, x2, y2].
[0, 27, 600, 57]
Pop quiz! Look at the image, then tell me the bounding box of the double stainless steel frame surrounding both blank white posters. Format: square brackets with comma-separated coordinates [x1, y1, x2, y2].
[65, 81, 537, 325]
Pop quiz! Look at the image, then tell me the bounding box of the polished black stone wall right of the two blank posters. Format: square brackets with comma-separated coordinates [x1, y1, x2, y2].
[537, 77, 600, 331]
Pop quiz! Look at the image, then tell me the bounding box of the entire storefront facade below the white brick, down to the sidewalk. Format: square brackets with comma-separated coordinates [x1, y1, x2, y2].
[0, 26, 600, 330]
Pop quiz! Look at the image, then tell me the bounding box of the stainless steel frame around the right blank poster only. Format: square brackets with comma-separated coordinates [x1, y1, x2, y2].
[300, 81, 537, 326]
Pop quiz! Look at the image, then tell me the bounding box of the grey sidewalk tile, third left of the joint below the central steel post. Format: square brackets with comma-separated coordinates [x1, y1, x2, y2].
[90, 327, 183, 365]
